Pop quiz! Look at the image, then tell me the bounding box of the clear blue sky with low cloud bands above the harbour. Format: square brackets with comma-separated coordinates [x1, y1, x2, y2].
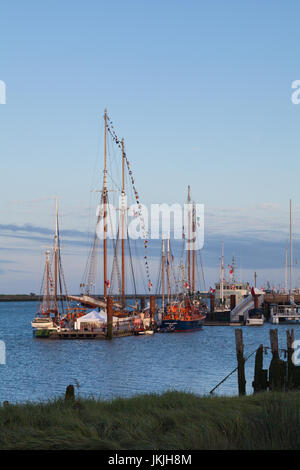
[0, 0, 300, 292]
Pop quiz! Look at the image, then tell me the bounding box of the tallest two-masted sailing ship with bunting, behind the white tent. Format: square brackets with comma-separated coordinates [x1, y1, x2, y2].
[69, 110, 152, 318]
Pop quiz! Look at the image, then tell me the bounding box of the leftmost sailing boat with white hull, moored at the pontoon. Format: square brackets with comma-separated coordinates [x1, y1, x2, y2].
[31, 197, 84, 337]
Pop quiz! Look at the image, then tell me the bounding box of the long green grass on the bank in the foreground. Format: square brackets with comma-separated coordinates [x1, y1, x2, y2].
[0, 392, 300, 450]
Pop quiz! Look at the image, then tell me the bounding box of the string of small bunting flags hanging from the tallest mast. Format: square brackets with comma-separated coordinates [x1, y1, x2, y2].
[107, 115, 152, 292]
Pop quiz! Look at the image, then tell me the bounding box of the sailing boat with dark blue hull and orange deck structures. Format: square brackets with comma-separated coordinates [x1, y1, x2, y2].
[161, 186, 207, 332]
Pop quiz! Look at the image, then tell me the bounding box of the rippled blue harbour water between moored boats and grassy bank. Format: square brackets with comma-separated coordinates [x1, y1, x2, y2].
[0, 302, 300, 402]
